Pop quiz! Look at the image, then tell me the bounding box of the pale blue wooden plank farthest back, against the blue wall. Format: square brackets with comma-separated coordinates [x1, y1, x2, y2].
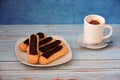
[0, 24, 120, 34]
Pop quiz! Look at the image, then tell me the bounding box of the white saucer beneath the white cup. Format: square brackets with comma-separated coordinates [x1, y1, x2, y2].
[77, 34, 110, 49]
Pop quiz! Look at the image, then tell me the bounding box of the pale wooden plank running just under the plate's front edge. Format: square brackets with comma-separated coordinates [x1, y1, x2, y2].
[0, 60, 120, 71]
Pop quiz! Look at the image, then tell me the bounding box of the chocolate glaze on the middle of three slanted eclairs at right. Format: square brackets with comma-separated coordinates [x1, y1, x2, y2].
[39, 40, 61, 53]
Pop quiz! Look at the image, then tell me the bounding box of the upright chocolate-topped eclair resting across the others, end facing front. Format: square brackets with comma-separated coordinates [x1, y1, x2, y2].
[28, 34, 39, 64]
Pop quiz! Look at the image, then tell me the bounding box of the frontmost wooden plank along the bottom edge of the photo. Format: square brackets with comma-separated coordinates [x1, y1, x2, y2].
[0, 70, 120, 80]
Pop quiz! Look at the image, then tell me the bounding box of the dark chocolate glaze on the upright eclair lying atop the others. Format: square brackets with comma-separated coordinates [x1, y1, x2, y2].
[29, 34, 38, 55]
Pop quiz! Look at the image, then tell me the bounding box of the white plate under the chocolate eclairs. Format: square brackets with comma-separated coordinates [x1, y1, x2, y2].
[15, 36, 72, 67]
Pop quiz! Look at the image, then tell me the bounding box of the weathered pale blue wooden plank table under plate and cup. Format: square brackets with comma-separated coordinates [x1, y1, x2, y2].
[0, 24, 120, 80]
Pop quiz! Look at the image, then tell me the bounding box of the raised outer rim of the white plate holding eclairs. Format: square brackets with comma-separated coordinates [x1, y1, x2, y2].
[15, 35, 72, 67]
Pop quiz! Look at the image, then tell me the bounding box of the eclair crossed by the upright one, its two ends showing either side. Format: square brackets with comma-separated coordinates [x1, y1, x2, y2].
[19, 32, 46, 52]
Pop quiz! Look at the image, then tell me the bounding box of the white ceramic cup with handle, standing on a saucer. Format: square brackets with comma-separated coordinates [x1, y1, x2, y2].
[83, 14, 113, 44]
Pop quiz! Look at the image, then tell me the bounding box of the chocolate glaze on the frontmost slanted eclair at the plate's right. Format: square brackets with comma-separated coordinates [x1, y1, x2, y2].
[42, 46, 63, 58]
